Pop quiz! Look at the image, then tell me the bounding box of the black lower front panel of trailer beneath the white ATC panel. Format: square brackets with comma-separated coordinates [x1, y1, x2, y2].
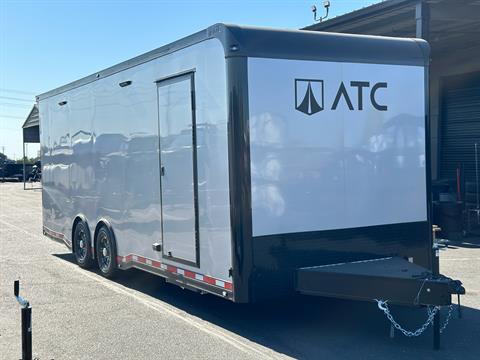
[248, 221, 432, 301]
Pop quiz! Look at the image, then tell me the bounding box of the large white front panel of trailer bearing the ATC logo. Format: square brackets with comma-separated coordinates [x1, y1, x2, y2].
[248, 58, 427, 236]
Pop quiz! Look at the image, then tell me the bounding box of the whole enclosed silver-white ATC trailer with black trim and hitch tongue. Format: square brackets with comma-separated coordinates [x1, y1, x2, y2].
[38, 24, 464, 348]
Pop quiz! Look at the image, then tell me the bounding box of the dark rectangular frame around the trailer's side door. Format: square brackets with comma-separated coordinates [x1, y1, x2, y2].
[155, 69, 200, 268]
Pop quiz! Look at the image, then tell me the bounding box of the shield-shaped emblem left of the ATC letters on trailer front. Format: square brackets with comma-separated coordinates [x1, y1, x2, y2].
[295, 79, 323, 115]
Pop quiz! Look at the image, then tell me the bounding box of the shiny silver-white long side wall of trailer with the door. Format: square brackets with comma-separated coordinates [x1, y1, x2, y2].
[39, 35, 231, 292]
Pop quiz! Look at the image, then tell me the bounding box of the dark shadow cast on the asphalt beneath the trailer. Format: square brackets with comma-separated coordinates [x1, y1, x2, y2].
[54, 253, 480, 360]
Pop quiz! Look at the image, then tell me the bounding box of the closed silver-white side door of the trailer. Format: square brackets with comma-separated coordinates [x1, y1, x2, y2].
[157, 72, 199, 266]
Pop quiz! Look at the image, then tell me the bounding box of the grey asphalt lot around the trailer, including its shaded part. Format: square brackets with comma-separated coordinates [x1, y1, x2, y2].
[0, 183, 480, 360]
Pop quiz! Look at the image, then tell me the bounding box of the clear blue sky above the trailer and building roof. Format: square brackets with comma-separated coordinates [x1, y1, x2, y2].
[0, 0, 379, 158]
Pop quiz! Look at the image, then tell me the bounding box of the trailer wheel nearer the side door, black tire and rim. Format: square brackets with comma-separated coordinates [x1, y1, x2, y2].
[95, 225, 117, 279]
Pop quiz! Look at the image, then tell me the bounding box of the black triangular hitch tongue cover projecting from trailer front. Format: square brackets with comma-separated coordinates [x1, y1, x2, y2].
[295, 257, 465, 306]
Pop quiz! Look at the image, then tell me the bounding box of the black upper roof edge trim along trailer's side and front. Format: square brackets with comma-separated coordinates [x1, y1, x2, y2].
[37, 24, 429, 101]
